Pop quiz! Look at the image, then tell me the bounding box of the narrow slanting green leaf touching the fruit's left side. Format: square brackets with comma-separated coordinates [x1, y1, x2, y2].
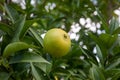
[29, 28, 43, 47]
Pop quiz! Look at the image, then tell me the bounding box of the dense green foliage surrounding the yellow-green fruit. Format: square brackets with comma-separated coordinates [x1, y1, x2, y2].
[0, 0, 120, 80]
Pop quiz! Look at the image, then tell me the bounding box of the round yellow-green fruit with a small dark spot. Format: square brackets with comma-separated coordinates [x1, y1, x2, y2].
[43, 28, 71, 57]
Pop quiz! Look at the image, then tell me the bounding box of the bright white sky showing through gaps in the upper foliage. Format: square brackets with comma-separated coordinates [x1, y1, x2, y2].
[12, 0, 120, 40]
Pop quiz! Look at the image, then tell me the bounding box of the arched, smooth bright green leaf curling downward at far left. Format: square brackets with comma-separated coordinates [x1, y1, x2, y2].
[3, 42, 33, 57]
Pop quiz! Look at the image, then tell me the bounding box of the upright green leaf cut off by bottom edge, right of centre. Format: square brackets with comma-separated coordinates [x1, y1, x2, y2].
[90, 64, 105, 80]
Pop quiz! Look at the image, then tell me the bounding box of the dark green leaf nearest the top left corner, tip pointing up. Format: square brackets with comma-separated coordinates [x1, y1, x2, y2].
[4, 4, 19, 23]
